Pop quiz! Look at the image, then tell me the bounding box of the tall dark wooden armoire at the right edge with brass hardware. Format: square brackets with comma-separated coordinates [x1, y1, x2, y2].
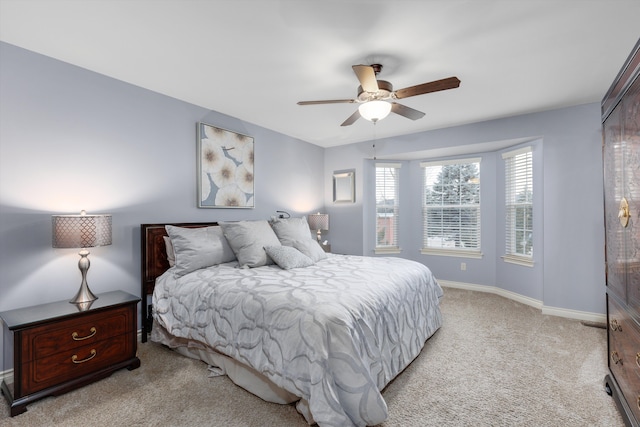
[602, 40, 640, 426]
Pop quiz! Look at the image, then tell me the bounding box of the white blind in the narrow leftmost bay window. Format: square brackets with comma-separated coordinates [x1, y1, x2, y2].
[376, 163, 402, 251]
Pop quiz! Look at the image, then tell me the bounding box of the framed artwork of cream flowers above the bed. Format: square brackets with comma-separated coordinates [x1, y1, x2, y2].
[197, 123, 255, 208]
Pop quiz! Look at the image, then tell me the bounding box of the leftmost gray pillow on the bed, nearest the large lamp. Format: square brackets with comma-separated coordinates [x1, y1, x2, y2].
[165, 225, 236, 277]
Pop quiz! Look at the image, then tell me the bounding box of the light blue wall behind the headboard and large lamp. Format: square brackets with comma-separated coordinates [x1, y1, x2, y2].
[0, 43, 325, 364]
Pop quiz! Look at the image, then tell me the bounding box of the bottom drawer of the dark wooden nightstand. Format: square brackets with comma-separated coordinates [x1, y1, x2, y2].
[22, 334, 135, 394]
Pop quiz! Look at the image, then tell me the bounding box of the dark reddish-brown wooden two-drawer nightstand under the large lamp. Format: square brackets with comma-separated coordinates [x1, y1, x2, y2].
[0, 291, 140, 417]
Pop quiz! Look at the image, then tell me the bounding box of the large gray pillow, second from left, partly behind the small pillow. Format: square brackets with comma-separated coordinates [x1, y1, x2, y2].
[220, 221, 280, 267]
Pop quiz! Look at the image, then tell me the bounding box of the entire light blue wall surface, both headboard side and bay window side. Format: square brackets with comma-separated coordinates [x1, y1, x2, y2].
[0, 38, 605, 370]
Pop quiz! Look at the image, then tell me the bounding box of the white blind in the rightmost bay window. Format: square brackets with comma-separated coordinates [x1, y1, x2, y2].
[502, 147, 533, 258]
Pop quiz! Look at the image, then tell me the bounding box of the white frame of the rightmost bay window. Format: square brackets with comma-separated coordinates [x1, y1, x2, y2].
[502, 146, 534, 267]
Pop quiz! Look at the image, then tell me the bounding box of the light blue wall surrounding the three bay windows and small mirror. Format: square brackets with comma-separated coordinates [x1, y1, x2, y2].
[324, 103, 606, 314]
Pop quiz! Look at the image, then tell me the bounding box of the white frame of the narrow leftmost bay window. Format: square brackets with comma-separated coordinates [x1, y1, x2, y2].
[374, 162, 402, 254]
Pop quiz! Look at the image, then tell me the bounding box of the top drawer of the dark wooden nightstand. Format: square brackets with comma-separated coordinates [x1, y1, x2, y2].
[22, 307, 133, 362]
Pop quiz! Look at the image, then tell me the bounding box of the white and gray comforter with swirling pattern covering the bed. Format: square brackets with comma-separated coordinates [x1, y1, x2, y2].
[153, 255, 442, 426]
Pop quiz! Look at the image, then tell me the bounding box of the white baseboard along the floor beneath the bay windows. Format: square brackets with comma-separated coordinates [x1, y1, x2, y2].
[438, 279, 607, 324]
